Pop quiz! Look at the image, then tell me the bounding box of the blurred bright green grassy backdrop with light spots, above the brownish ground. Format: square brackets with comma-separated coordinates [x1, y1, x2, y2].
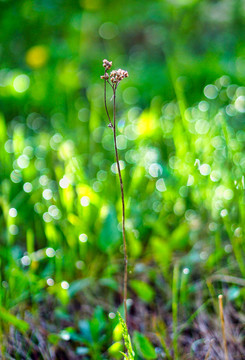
[0, 0, 245, 359]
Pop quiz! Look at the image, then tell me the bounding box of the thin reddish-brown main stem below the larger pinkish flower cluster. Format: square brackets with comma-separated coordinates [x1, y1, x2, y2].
[113, 88, 128, 324]
